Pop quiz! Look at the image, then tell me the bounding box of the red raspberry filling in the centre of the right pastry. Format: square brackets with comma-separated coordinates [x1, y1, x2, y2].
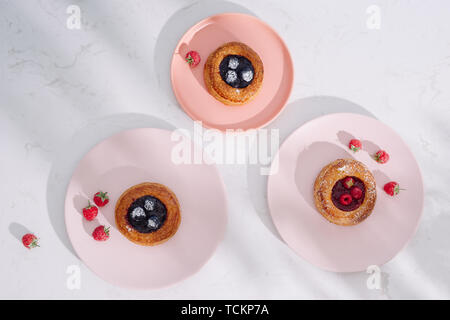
[331, 177, 366, 211]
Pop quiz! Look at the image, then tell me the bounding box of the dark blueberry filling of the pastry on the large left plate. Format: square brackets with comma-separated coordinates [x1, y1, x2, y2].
[127, 196, 167, 233]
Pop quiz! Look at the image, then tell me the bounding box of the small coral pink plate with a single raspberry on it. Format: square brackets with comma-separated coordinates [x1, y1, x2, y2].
[171, 13, 294, 130]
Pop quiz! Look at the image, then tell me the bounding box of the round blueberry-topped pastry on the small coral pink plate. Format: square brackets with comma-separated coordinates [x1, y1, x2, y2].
[203, 42, 264, 105]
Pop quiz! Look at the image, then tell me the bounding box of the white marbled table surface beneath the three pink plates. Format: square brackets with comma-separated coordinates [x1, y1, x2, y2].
[0, 0, 450, 299]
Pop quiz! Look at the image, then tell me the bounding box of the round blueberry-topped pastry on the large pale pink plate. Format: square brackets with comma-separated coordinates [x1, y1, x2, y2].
[115, 182, 181, 246]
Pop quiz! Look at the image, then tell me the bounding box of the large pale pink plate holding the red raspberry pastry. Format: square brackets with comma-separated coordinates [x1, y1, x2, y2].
[268, 113, 424, 272]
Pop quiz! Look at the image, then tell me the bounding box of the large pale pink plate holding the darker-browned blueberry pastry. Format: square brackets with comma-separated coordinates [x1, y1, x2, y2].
[65, 129, 227, 289]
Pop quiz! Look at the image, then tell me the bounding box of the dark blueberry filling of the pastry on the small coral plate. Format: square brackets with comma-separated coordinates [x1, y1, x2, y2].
[219, 55, 255, 89]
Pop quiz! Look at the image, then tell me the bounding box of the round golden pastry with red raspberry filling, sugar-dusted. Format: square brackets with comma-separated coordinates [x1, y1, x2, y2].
[314, 159, 377, 226]
